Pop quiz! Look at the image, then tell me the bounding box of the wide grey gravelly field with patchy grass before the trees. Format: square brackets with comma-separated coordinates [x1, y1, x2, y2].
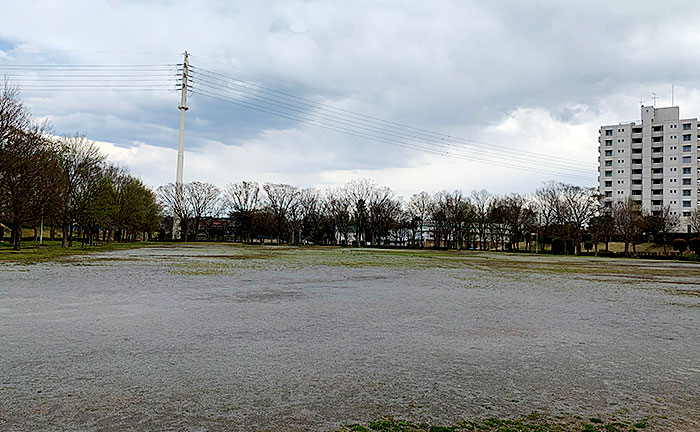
[0, 245, 700, 431]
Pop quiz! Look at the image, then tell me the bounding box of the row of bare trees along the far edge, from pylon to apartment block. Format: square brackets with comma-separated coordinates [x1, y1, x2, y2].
[156, 179, 700, 254]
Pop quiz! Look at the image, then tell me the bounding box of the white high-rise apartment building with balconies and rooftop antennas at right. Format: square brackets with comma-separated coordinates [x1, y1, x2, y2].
[598, 105, 700, 232]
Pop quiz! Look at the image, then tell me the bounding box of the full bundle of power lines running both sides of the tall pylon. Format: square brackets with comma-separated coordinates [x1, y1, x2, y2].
[0, 57, 594, 178]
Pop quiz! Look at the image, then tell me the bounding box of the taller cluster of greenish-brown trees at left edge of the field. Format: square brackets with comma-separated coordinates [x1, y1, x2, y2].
[0, 82, 161, 250]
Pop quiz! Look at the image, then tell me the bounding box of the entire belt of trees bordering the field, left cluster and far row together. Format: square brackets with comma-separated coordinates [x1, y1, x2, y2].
[0, 83, 700, 254]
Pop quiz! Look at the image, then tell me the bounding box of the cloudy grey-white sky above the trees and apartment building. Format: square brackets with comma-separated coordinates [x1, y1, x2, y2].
[0, 0, 700, 197]
